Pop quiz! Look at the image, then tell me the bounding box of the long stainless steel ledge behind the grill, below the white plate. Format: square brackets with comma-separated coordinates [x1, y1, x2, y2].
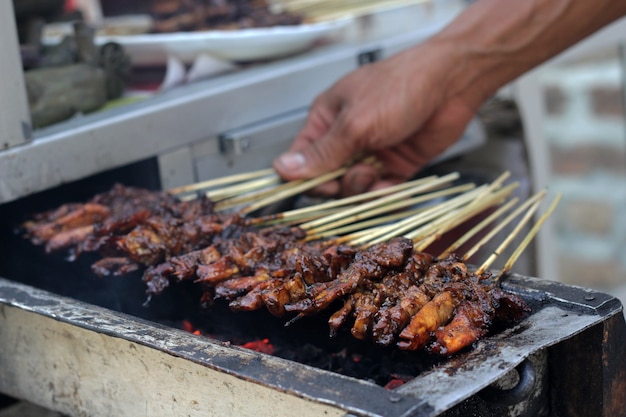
[0, 5, 458, 203]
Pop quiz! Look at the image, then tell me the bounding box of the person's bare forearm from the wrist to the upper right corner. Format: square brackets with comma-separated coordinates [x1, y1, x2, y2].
[428, 0, 626, 101]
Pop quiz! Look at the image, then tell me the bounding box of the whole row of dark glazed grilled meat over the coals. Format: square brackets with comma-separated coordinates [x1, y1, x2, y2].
[24, 186, 529, 355]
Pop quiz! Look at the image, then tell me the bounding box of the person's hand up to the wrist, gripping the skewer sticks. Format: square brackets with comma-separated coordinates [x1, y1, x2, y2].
[274, 41, 480, 196]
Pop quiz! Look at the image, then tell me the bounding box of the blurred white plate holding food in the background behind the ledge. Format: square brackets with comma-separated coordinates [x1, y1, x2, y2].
[96, 19, 351, 66]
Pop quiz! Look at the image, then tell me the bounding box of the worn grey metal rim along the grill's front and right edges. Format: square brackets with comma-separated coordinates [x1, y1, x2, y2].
[0, 274, 623, 417]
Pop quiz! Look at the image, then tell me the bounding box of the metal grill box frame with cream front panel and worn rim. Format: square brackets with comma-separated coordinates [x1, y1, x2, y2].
[0, 274, 626, 417]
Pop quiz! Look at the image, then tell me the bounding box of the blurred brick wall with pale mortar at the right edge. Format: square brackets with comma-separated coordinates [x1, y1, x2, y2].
[541, 53, 626, 300]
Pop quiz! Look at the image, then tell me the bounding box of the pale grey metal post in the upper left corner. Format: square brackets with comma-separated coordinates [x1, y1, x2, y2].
[0, 1, 32, 150]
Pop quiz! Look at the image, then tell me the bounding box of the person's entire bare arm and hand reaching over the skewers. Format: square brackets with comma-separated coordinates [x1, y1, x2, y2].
[274, 0, 626, 195]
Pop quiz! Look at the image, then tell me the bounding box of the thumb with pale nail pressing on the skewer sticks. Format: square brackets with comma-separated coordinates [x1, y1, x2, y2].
[274, 129, 356, 180]
